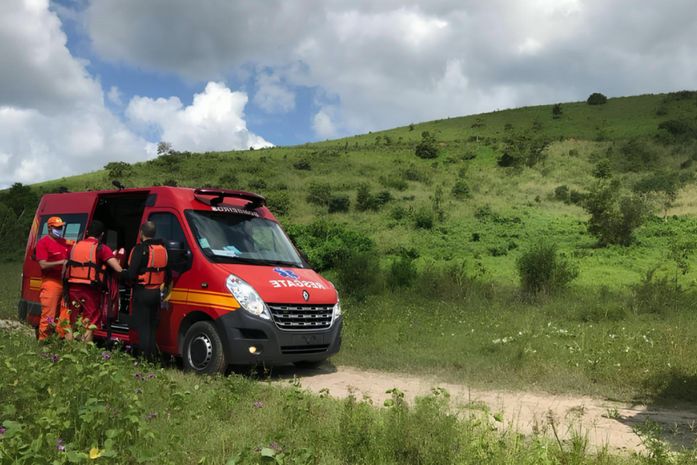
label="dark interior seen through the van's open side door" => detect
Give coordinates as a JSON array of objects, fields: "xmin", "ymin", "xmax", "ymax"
[{"xmin": 93, "ymin": 192, "xmax": 148, "ymax": 332}]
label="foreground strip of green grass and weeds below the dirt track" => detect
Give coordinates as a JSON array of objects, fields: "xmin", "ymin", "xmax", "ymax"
[{"xmin": 0, "ymin": 330, "xmax": 694, "ymax": 465}]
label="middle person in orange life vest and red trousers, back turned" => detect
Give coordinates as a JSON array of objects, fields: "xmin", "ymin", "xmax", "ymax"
[{"xmin": 59, "ymin": 220, "xmax": 123, "ymax": 342}]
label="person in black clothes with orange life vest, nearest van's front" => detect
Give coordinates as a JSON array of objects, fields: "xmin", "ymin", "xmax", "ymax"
[{"xmin": 124, "ymin": 221, "xmax": 170, "ymax": 361}]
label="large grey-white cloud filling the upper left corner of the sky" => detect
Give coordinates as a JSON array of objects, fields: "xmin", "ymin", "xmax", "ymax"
[{"xmin": 0, "ymin": 0, "xmax": 146, "ymax": 187}]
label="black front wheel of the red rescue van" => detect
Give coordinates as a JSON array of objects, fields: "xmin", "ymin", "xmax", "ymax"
[{"xmin": 182, "ymin": 321, "xmax": 227, "ymax": 374}]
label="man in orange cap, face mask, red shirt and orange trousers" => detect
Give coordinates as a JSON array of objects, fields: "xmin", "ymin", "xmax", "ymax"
[{"xmin": 36, "ymin": 216, "xmax": 72, "ymax": 341}]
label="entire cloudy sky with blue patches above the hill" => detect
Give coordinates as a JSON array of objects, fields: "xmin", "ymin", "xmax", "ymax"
[{"xmin": 0, "ymin": 0, "xmax": 697, "ymax": 188}]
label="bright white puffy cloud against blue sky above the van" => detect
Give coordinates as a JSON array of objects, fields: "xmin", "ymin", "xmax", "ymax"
[{"xmin": 126, "ymin": 82, "xmax": 273, "ymax": 151}]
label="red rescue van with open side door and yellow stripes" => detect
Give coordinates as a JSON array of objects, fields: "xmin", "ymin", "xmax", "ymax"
[{"xmin": 19, "ymin": 187, "xmax": 342, "ymax": 373}]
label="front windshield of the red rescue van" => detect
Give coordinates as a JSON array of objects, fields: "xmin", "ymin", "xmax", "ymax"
[{"xmin": 186, "ymin": 210, "xmax": 304, "ymax": 268}]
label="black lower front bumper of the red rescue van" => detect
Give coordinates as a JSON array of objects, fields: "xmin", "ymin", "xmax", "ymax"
[{"xmin": 216, "ymin": 309, "xmax": 343, "ymax": 365}]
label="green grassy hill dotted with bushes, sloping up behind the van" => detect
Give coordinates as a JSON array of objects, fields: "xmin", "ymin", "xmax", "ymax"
[{"xmin": 25, "ymin": 92, "xmax": 697, "ymax": 287}]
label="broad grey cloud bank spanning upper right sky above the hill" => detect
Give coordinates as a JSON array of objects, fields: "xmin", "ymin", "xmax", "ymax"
[{"xmin": 87, "ymin": 0, "xmax": 697, "ymax": 138}]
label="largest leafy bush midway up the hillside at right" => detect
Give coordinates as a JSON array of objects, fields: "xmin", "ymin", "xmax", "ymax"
[{"xmin": 583, "ymin": 182, "xmax": 649, "ymax": 246}]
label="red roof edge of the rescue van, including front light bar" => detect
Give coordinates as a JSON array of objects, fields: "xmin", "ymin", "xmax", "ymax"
[{"xmin": 39, "ymin": 186, "xmax": 276, "ymax": 221}]
